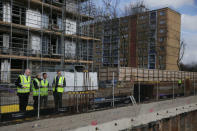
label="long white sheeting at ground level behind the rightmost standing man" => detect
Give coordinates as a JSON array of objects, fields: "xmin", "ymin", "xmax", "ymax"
[{"xmin": 43, "ymin": 72, "xmax": 98, "ymax": 92}]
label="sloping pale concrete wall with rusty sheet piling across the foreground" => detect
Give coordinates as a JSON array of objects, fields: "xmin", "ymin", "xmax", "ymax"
[{"xmin": 1, "ymin": 96, "xmax": 197, "ymax": 131}]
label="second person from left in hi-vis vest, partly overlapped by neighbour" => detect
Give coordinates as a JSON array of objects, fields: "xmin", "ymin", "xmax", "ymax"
[{"xmin": 32, "ymin": 74, "xmax": 41, "ymax": 111}]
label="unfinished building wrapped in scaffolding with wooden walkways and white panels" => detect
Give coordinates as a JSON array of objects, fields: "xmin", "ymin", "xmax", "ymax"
[{"xmin": 0, "ymin": 0, "xmax": 98, "ymax": 83}]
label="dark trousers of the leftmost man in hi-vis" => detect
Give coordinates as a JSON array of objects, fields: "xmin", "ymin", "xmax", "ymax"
[{"xmin": 17, "ymin": 93, "xmax": 29, "ymax": 112}]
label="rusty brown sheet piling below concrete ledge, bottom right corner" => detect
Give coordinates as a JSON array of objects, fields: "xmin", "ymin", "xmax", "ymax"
[{"xmin": 131, "ymin": 111, "xmax": 197, "ymax": 131}]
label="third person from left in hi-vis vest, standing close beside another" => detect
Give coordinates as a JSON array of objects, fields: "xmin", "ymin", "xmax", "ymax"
[{"xmin": 40, "ymin": 73, "xmax": 49, "ymax": 107}]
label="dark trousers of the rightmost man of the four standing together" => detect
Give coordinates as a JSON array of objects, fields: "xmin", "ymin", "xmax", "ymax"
[{"xmin": 53, "ymin": 92, "xmax": 62, "ymax": 111}]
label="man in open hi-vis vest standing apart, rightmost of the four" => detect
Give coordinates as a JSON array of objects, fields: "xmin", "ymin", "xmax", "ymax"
[{"xmin": 52, "ymin": 71, "xmax": 66, "ymax": 111}]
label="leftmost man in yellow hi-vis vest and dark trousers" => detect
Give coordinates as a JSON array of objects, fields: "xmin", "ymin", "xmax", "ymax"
[{"xmin": 15, "ymin": 69, "xmax": 31, "ymax": 112}]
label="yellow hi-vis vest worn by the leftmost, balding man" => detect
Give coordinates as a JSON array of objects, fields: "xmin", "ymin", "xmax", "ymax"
[{"xmin": 17, "ymin": 75, "xmax": 31, "ymax": 93}]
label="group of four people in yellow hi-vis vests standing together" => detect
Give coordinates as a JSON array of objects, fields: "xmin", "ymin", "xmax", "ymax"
[{"xmin": 15, "ymin": 69, "xmax": 66, "ymax": 112}]
